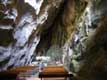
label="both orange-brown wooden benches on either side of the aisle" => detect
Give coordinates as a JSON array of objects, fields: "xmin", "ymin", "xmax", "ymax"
[{"xmin": 0, "ymin": 66, "xmax": 73, "ymax": 79}]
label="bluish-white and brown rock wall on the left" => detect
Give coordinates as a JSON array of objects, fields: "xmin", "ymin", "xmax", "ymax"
[{"xmin": 0, "ymin": 0, "xmax": 63, "ymax": 70}]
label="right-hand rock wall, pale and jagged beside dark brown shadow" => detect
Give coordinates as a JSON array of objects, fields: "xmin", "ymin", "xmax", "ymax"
[{"xmin": 71, "ymin": 0, "xmax": 107, "ymax": 80}]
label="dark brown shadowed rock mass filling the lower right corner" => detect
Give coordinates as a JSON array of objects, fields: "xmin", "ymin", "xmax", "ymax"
[{"xmin": 77, "ymin": 18, "xmax": 107, "ymax": 80}]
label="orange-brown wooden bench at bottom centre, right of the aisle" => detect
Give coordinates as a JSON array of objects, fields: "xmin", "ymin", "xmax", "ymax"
[{"xmin": 39, "ymin": 66, "xmax": 73, "ymax": 80}]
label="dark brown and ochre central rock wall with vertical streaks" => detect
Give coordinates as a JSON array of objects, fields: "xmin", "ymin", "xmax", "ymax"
[{"xmin": 36, "ymin": 0, "xmax": 87, "ymax": 54}]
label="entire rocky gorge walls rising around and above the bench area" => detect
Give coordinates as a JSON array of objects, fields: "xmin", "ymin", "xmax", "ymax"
[{"xmin": 0, "ymin": 0, "xmax": 107, "ymax": 80}]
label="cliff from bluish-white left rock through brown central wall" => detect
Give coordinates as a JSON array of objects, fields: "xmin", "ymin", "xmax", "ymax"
[{"xmin": 0, "ymin": 0, "xmax": 87, "ymax": 70}]
